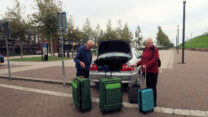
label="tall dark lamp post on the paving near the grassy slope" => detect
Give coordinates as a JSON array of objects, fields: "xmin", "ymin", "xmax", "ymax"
[{"xmin": 182, "ymin": 0, "xmax": 186, "ymax": 64}]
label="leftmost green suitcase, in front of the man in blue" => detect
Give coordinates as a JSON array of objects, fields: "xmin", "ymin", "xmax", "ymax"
[{"xmin": 72, "ymin": 76, "xmax": 92, "ymax": 112}]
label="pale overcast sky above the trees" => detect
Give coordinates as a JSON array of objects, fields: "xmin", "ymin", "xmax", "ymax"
[{"xmin": 0, "ymin": 0, "xmax": 208, "ymax": 43}]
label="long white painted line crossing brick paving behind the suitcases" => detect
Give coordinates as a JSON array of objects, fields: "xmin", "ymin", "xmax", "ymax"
[{"xmin": 0, "ymin": 84, "xmax": 208, "ymax": 117}]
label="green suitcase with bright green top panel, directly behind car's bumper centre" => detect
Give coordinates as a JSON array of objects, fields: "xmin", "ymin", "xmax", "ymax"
[{"xmin": 99, "ymin": 77, "xmax": 122, "ymax": 113}]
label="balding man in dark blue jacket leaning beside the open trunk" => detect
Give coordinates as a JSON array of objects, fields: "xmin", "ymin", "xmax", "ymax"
[{"xmin": 74, "ymin": 40, "xmax": 94, "ymax": 78}]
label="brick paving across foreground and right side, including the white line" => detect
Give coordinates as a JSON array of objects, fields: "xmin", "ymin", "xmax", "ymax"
[{"xmin": 0, "ymin": 50, "xmax": 208, "ymax": 117}]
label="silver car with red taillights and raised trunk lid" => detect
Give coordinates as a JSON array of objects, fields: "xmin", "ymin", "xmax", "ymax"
[{"xmin": 89, "ymin": 41, "xmax": 141, "ymax": 84}]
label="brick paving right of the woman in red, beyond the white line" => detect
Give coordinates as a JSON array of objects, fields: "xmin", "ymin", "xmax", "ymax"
[{"xmin": 158, "ymin": 51, "xmax": 208, "ymax": 111}]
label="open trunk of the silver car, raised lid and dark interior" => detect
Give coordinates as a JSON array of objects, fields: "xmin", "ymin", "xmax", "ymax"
[{"xmin": 95, "ymin": 40, "xmax": 132, "ymax": 71}]
